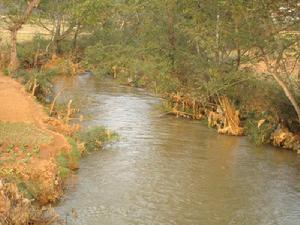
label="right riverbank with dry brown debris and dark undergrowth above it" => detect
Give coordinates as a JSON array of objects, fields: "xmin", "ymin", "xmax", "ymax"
[{"xmin": 103, "ymin": 74, "xmax": 300, "ymax": 154}]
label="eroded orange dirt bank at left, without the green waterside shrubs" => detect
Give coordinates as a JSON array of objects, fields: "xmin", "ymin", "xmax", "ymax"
[{"xmin": 0, "ymin": 74, "xmax": 71, "ymax": 225}]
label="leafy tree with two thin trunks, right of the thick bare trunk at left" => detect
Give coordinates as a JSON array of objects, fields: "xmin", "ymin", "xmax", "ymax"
[{"xmin": 36, "ymin": 0, "xmax": 107, "ymax": 55}]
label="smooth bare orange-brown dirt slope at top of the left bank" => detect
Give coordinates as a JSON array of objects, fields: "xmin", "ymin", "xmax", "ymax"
[{"xmin": 0, "ymin": 73, "xmax": 70, "ymax": 158}]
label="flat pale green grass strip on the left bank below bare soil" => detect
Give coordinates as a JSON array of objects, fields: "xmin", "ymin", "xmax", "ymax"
[{"xmin": 0, "ymin": 122, "xmax": 52, "ymax": 146}]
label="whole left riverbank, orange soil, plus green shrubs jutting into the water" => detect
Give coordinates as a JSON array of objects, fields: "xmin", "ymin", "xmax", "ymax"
[{"xmin": 0, "ymin": 74, "xmax": 113, "ymax": 225}]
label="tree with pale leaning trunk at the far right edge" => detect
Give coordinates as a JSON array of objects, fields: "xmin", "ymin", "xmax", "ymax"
[{"xmin": 245, "ymin": 0, "xmax": 300, "ymax": 122}]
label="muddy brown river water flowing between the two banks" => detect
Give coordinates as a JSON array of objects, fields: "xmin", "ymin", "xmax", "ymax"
[{"xmin": 57, "ymin": 75, "xmax": 300, "ymax": 225}]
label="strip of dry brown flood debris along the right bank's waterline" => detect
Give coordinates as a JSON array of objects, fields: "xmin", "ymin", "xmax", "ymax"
[{"xmin": 164, "ymin": 93, "xmax": 300, "ymax": 154}]
